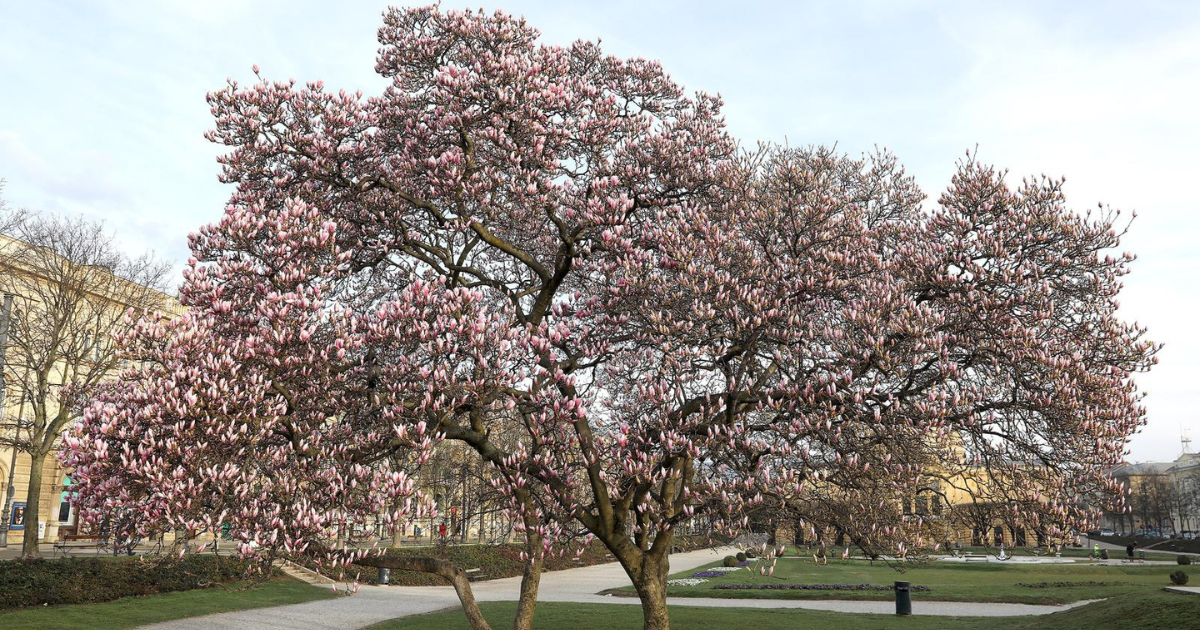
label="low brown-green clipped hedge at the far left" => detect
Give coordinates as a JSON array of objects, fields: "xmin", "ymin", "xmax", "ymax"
[{"xmin": 0, "ymin": 556, "xmax": 252, "ymax": 610}]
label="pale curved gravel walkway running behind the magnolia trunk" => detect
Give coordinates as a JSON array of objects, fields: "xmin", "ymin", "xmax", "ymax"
[{"xmin": 133, "ymin": 550, "xmax": 1104, "ymax": 630}]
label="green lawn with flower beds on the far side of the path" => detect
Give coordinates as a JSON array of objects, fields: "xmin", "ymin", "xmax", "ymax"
[{"xmin": 612, "ymin": 557, "xmax": 1185, "ymax": 607}]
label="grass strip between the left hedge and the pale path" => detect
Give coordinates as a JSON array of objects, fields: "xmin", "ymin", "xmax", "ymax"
[{"xmin": 0, "ymin": 577, "xmax": 336, "ymax": 630}]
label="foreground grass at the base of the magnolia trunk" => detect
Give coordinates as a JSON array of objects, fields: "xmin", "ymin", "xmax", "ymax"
[{"xmin": 371, "ymin": 590, "xmax": 1200, "ymax": 630}]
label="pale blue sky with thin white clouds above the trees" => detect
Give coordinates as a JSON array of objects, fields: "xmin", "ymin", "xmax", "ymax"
[{"xmin": 0, "ymin": 0, "xmax": 1200, "ymax": 461}]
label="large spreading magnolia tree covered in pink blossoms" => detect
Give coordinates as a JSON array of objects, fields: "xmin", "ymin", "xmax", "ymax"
[{"xmin": 68, "ymin": 8, "xmax": 1154, "ymax": 629}]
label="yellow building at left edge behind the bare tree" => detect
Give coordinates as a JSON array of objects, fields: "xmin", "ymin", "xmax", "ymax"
[{"xmin": 0, "ymin": 229, "xmax": 181, "ymax": 550}]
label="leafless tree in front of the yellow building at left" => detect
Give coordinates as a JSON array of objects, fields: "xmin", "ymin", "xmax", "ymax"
[{"xmin": 0, "ymin": 209, "xmax": 172, "ymax": 558}]
